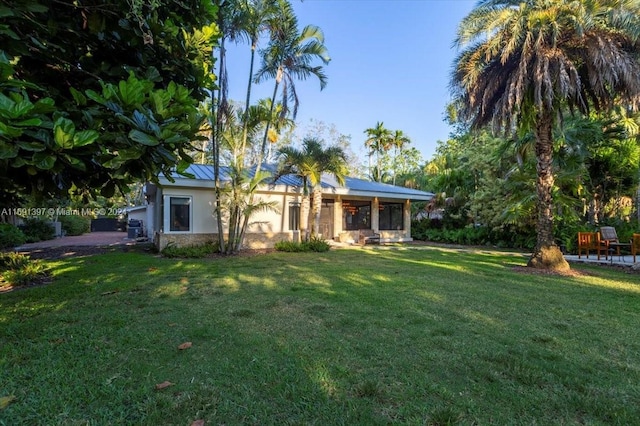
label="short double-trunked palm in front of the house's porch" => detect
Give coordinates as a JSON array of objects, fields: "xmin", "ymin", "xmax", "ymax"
[{"xmin": 275, "ymin": 138, "xmax": 347, "ymax": 240}]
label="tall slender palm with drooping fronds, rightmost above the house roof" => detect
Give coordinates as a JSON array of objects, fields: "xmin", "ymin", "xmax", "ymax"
[{"xmin": 255, "ymin": 0, "xmax": 330, "ymax": 166}]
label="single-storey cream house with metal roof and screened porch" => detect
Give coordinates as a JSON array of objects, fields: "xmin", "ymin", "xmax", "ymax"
[{"xmin": 138, "ymin": 164, "xmax": 433, "ymax": 250}]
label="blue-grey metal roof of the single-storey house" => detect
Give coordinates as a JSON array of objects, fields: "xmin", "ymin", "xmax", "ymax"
[{"xmin": 163, "ymin": 164, "xmax": 434, "ymax": 201}]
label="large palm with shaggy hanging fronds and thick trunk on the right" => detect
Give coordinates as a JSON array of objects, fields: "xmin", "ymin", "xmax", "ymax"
[{"xmin": 451, "ymin": 0, "xmax": 640, "ymax": 269}]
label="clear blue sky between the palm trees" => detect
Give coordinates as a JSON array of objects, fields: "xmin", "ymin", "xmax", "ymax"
[{"xmin": 228, "ymin": 0, "xmax": 476, "ymax": 161}]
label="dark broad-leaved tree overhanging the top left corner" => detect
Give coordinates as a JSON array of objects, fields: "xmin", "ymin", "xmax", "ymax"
[{"xmin": 0, "ymin": 0, "xmax": 217, "ymax": 203}]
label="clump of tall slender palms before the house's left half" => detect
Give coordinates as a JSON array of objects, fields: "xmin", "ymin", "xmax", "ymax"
[{"xmin": 211, "ymin": 0, "xmax": 329, "ymax": 254}]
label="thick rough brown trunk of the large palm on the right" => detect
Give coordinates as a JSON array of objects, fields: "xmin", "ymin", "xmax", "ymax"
[{"xmin": 527, "ymin": 110, "xmax": 570, "ymax": 271}]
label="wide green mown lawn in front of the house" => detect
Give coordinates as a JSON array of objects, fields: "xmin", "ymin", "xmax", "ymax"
[{"xmin": 0, "ymin": 248, "xmax": 640, "ymax": 425}]
